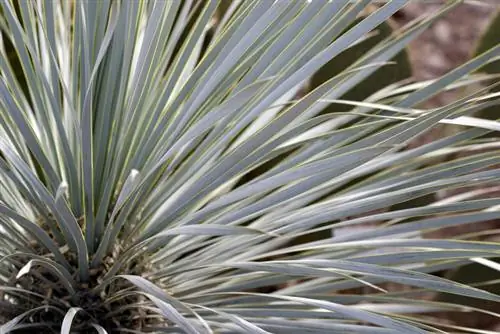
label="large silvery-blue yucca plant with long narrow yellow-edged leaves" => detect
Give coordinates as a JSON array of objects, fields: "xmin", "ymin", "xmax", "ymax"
[{"xmin": 0, "ymin": 0, "xmax": 500, "ymax": 334}]
